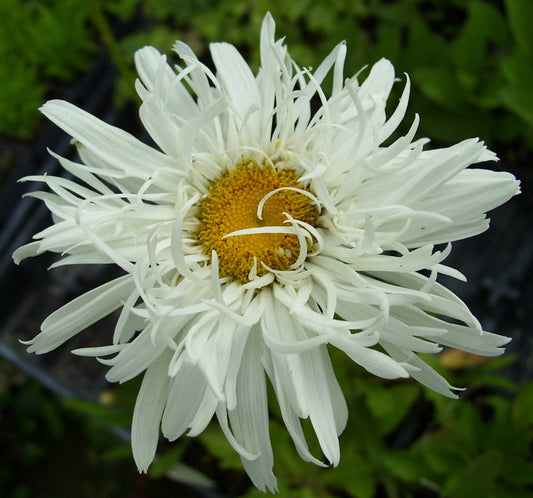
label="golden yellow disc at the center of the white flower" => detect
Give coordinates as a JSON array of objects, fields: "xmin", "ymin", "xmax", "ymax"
[{"xmin": 195, "ymin": 161, "xmax": 319, "ymax": 283}]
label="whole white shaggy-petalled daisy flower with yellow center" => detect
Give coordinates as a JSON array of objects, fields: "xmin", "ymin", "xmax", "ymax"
[{"xmin": 14, "ymin": 15, "xmax": 519, "ymax": 491}]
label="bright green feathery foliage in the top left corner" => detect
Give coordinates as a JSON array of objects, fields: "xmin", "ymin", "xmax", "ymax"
[{"xmin": 0, "ymin": 0, "xmax": 96, "ymax": 139}]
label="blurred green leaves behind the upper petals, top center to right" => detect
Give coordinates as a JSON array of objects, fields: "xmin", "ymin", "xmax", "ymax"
[{"xmin": 115, "ymin": 0, "xmax": 533, "ymax": 159}]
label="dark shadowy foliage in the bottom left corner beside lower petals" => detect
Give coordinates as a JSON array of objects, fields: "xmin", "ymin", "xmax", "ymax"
[{"xmin": 0, "ymin": 359, "xmax": 193, "ymax": 498}]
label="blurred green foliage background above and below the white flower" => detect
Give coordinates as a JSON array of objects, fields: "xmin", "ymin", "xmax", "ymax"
[{"xmin": 0, "ymin": 0, "xmax": 533, "ymax": 498}]
